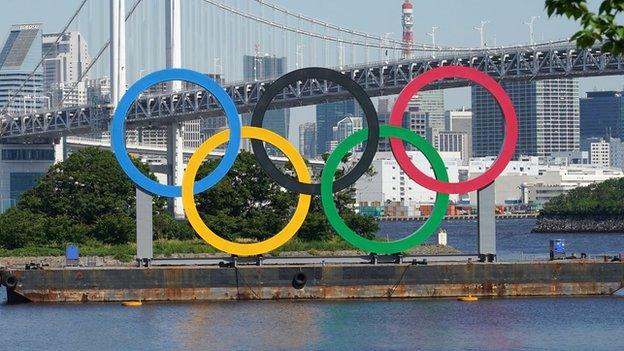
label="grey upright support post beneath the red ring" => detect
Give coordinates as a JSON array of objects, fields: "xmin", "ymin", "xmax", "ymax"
[{"xmin": 477, "ymin": 182, "xmax": 496, "ymax": 262}]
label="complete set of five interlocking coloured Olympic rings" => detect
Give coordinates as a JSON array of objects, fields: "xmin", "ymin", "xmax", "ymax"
[{"xmin": 111, "ymin": 66, "xmax": 518, "ymax": 256}]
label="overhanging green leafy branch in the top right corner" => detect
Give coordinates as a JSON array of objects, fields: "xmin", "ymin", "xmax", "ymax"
[{"xmin": 546, "ymin": 0, "xmax": 624, "ymax": 54}]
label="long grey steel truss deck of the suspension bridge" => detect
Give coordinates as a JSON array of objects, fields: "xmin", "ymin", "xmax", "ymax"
[{"xmin": 0, "ymin": 44, "xmax": 624, "ymax": 139}]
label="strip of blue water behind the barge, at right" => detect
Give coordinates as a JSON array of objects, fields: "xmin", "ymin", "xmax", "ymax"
[{"xmin": 377, "ymin": 219, "xmax": 624, "ymax": 260}]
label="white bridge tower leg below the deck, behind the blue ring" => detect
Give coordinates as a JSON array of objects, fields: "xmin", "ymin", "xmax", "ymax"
[{"xmin": 167, "ymin": 122, "xmax": 184, "ymax": 219}]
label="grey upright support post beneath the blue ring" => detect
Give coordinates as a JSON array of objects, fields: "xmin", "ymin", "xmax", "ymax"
[{"xmin": 136, "ymin": 188, "xmax": 154, "ymax": 267}]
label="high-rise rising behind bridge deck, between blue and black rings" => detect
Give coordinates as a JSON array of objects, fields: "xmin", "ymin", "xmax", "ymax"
[{"xmin": 243, "ymin": 54, "xmax": 290, "ymax": 147}]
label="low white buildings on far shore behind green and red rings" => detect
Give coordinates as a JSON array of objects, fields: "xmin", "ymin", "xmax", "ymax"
[{"xmin": 356, "ymin": 151, "xmax": 624, "ymax": 208}]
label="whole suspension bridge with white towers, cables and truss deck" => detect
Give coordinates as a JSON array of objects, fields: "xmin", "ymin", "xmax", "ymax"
[{"xmin": 0, "ymin": 0, "xmax": 624, "ymax": 223}]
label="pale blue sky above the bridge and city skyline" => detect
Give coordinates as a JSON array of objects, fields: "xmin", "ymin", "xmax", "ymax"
[{"xmin": 0, "ymin": 0, "xmax": 624, "ymax": 145}]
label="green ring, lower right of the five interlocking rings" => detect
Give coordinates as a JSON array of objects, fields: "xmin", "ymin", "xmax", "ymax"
[{"xmin": 321, "ymin": 125, "xmax": 449, "ymax": 254}]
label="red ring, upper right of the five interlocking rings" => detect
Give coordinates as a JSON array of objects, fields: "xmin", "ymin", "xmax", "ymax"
[{"xmin": 390, "ymin": 66, "xmax": 518, "ymax": 194}]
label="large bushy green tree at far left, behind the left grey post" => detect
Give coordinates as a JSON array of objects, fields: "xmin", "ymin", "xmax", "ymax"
[{"xmin": 0, "ymin": 148, "xmax": 185, "ymax": 249}]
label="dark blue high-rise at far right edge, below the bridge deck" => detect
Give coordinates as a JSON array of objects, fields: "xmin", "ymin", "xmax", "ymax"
[{"xmin": 580, "ymin": 91, "xmax": 624, "ymax": 143}]
